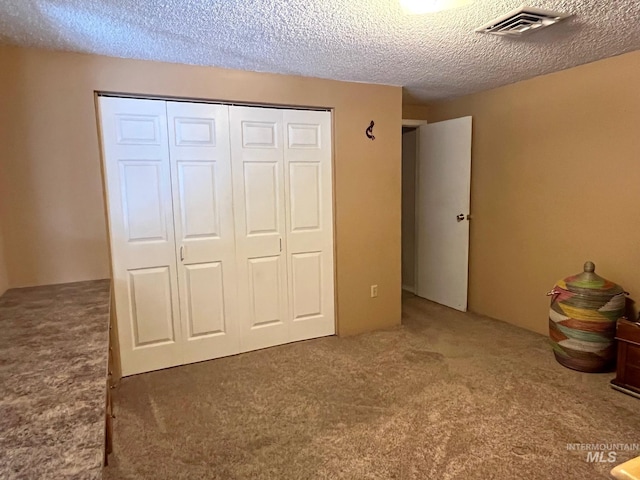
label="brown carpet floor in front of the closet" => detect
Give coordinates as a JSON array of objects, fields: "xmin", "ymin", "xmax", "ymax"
[{"xmin": 104, "ymin": 296, "xmax": 640, "ymax": 480}]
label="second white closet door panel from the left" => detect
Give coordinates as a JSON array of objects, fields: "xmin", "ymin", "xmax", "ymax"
[{"xmin": 167, "ymin": 102, "xmax": 240, "ymax": 363}]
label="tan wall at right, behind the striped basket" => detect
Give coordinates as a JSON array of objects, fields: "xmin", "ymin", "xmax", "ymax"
[{"xmin": 429, "ymin": 51, "xmax": 640, "ymax": 333}]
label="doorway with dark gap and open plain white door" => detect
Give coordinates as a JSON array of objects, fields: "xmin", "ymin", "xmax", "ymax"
[{"xmin": 401, "ymin": 117, "xmax": 472, "ymax": 311}]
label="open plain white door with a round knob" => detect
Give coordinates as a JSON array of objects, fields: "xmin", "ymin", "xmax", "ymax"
[{"xmin": 416, "ymin": 117, "xmax": 471, "ymax": 312}]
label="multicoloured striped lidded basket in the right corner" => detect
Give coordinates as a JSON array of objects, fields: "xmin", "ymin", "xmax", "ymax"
[{"xmin": 547, "ymin": 262, "xmax": 626, "ymax": 372}]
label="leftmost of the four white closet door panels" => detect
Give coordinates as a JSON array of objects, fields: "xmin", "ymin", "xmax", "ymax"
[{"xmin": 99, "ymin": 97, "xmax": 183, "ymax": 375}]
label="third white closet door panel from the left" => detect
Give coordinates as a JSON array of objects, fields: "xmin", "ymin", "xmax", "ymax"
[{"xmin": 229, "ymin": 107, "xmax": 290, "ymax": 351}]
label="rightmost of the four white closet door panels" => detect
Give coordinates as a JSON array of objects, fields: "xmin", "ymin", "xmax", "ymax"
[{"xmin": 283, "ymin": 110, "xmax": 335, "ymax": 341}]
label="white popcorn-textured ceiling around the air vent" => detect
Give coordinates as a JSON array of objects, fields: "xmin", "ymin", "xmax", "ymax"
[{"xmin": 0, "ymin": 0, "xmax": 640, "ymax": 103}]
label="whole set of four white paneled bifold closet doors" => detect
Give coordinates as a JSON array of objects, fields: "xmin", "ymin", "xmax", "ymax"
[{"xmin": 100, "ymin": 97, "xmax": 335, "ymax": 375}]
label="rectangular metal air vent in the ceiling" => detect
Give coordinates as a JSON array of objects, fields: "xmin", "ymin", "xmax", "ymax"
[{"xmin": 476, "ymin": 7, "xmax": 571, "ymax": 37}]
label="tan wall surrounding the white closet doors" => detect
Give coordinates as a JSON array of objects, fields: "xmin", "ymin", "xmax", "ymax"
[{"xmin": 0, "ymin": 47, "xmax": 402, "ymax": 334}]
